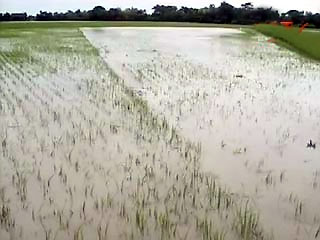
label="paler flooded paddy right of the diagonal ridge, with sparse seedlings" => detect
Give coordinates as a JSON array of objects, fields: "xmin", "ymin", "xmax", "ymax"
[{"xmin": 83, "ymin": 28, "xmax": 320, "ymax": 240}]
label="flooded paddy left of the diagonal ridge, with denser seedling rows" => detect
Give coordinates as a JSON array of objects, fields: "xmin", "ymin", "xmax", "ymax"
[{"xmin": 0, "ymin": 29, "xmax": 212, "ymax": 240}]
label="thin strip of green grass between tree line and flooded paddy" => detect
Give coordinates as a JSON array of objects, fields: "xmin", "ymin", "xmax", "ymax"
[{"xmin": 0, "ymin": 21, "xmax": 250, "ymax": 30}]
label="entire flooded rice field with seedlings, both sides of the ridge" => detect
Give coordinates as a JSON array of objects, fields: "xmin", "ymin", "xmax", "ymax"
[{"xmin": 0, "ymin": 23, "xmax": 320, "ymax": 240}]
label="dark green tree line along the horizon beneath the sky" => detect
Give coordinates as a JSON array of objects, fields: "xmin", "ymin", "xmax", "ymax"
[{"xmin": 0, "ymin": 2, "xmax": 320, "ymax": 28}]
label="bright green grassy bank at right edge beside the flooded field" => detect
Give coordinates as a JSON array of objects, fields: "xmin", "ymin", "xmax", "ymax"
[{"xmin": 255, "ymin": 24, "xmax": 320, "ymax": 61}]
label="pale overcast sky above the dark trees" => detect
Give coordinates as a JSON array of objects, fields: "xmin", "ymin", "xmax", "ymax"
[{"xmin": 0, "ymin": 0, "xmax": 320, "ymax": 14}]
